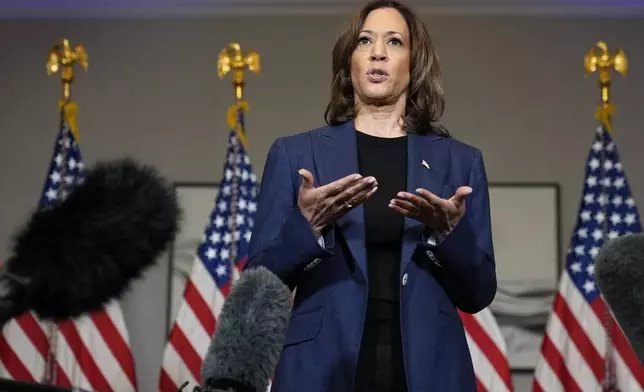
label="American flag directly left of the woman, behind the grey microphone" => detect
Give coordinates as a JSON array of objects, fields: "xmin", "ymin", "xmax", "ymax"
[{"xmin": 159, "ymin": 105, "xmax": 258, "ymax": 392}]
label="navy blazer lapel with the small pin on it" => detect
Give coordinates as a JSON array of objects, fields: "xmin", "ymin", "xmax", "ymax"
[{"xmin": 400, "ymin": 133, "xmax": 449, "ymax": 274}]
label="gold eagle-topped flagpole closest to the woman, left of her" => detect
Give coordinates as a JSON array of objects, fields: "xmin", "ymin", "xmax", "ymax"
[{"xmin": 217, "ymin": 42, "xmax": 261, "ymax": 276}]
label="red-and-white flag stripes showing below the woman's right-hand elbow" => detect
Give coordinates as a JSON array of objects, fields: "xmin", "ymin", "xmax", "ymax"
[{"xmin": 459, "ymin": 308, "xmax": 514, "ymax": 392}]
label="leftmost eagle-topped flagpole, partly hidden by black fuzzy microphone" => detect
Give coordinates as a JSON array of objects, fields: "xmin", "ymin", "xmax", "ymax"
[{"xmin": 42, "ymin": 38, "xmax": 89, "ymax": 385}]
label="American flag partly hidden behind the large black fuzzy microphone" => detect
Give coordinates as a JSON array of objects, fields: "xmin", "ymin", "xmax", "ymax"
[{"xmin": 0, "ymin": 103, "xmax": 136, "ymax": 392}]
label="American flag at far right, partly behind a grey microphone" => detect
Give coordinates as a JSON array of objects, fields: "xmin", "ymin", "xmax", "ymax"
[{"xmin": 533, "ymin": 126, "xmax": 644, "ymax": 392}]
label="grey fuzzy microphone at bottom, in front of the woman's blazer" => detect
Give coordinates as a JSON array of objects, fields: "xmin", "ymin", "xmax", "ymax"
[{"xmin": 197, "ymin": 267, "xmax": 291, "ymax": 392}]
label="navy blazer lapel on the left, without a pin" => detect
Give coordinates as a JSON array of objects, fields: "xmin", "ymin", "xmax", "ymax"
[{"xmin": 312, "ymin": 121, "xmax": 367, "ymax": 280}]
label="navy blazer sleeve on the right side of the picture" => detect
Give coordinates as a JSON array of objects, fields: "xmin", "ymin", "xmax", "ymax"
[{"xmin": 421, "ymin": 151, "xmax": 497, "ymax": 313}]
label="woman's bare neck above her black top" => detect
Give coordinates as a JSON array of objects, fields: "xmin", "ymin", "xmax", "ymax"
[{"xmin": 354, "ymin": 95, "xmax": 405, "ymax": 138}]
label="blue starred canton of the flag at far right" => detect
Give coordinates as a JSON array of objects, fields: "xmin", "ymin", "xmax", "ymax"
[{"xmin": 566, "ymin": 126, "xmax": 642, "ymax": 303}]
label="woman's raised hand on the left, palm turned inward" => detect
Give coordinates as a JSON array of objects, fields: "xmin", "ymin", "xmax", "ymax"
[{"xmin": 297, "ymin": 169, "xmax": 378, "ymax": 237}]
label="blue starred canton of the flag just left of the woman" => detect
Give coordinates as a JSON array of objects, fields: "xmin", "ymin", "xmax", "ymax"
[{"xmin": 198, "ymin": 109, "xmax": 258, "ymax": 289}]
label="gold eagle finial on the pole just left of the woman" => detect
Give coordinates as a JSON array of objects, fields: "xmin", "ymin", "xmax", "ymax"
[{"xmin": 217, "ymin": 42, "xmax": 261, "ymax": 102}]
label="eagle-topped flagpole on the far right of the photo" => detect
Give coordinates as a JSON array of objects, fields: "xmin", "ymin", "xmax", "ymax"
[{"xmin": 584, "ymin": 41, "xmax": 628, "ymax": 392}]
